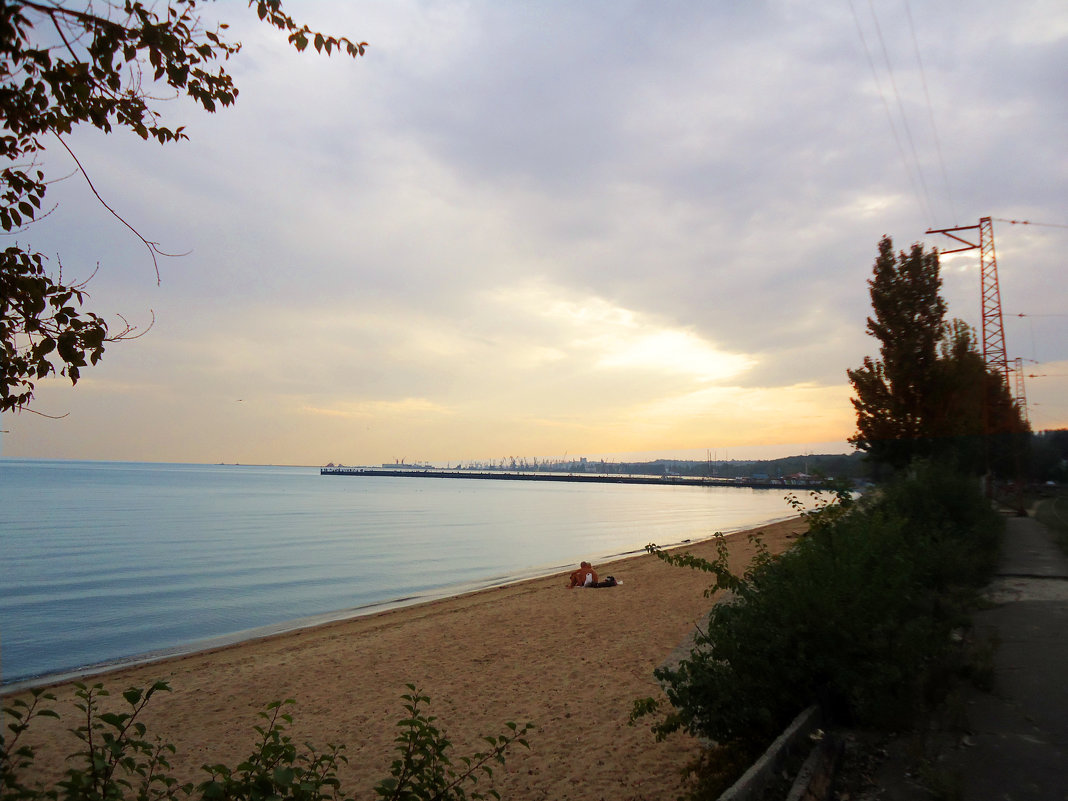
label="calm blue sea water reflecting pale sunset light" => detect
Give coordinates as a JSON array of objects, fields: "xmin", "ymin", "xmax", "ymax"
[{"xmin": 0, "ymin": 460, "xmax": 789, "ymax": 685}]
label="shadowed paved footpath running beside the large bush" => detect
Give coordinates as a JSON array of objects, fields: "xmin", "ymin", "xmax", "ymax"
[{"xmin": 927, "ymin": 517, "xmax": 1068, "ymax": 801}]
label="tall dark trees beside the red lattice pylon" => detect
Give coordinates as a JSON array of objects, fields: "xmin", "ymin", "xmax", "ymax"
[{"xmin": 848, "ymin": 237, "xmax": 1026, "ymax": 472}]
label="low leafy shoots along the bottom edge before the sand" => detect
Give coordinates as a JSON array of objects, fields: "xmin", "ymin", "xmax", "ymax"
[{"xmin": 0, "ymin": 681, "xmax": 533, "ymax": 801}]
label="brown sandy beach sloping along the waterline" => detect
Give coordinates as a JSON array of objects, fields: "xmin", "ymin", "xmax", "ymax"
[{"xmin": 10, "ymin": 519, "xmax": 804, "ymax": 801}]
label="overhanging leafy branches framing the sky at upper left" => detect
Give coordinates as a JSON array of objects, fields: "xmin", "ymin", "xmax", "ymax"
[{"xmin": 0, "ymin": 0, "xmax": 366, "ymax": 411}]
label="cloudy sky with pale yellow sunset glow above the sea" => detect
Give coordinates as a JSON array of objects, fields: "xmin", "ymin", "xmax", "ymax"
[{"xmin": 0, "ymin": 0, "xmax": 1068, "ymax": 466}]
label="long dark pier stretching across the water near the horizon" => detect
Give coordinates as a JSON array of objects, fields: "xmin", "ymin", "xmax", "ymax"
[{"xmin": 319, "ymin": 467, "xmax": 823, "ymax": 489}]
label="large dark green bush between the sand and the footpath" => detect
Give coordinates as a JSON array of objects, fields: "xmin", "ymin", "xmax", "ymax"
[{"xmin": 635, "ymin": 466, "xmax": 1001, "ymax": 754}]
